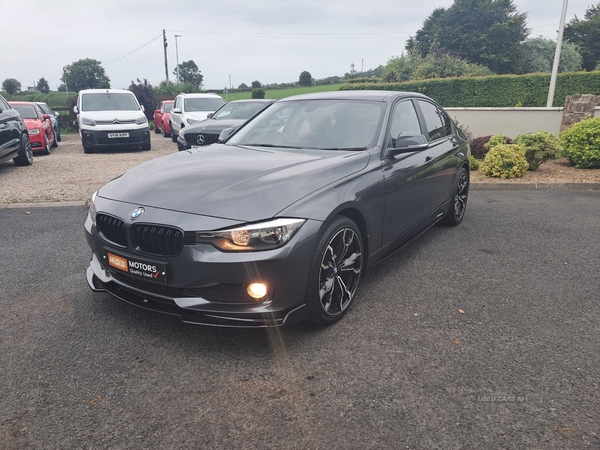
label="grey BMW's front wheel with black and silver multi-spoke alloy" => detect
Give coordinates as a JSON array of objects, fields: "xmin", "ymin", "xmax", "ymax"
[{"xmin": 305, "ymin": 216, "xmax": 364, "ymax": 325}]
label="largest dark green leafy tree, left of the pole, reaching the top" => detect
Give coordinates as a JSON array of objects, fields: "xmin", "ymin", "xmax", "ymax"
[{"xmin": 406, "ymin": 0, "xmax": 529, "ymax": 73}]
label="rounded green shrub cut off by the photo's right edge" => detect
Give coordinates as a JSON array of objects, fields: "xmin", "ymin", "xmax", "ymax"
[{"xmin": 560, "ymin": 117, "xmax": 600, "ymax": 169}]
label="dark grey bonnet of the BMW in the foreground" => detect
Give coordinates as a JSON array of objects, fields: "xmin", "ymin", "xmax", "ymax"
[{"xmin": 98, "ymin": 144, "xmax": 369, "ymax": 222}]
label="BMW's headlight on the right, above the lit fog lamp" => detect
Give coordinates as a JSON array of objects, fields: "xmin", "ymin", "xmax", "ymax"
[{"xmin": 196, "ymin": 219, "xmax": 306, "ymax": 252}]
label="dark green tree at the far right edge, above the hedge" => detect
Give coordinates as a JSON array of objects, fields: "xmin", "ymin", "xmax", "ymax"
[{"xmin": 564, "ymin": 2, "xmax": 600, "ymax": 70}]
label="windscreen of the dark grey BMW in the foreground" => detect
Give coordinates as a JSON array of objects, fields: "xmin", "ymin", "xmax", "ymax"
[{"xmin": 227, "ymin": 100, "xmax": 385, "ymax": 150}]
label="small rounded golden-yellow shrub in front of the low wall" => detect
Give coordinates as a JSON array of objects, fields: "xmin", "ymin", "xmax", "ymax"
[{"xmin": 480, "ymin": 144, "xmax": 529, "ymax": 178}]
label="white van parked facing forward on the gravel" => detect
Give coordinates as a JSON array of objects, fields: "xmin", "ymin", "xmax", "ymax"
[{"xmin": 73, "ymin": 89, "xmax": 151, "ymax": 153}]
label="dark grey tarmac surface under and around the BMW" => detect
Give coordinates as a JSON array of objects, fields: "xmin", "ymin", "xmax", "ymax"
[{"xmin": 0, "ymin": 186, "xmax": 600, "ymax": 449}]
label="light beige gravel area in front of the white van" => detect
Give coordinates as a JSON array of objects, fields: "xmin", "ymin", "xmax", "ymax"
[{"xmin": 0, "ymin": 131, "xmax": 177, "ymax": 204}]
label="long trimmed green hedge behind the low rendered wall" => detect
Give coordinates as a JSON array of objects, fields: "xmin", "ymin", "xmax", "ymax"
[{"xmin": 340, "ymin": 71, "xmax": 600, "ymax": 108}]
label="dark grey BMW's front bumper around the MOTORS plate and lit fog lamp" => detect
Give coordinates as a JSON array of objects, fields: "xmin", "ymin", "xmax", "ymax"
[{"xmin": 84, "ymin": 207, "xmax": 319, "ymax": 328}]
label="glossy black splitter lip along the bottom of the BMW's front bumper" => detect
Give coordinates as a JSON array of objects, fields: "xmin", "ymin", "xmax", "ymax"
[{"xmin": 86, "ymin": 254, "xmax": 308, "ymax": 328}]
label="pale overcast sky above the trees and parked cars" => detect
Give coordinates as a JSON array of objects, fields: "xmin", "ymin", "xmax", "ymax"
[{"xmin": 0, "ymin": 0, "xmax": 598, "ymax": 91}]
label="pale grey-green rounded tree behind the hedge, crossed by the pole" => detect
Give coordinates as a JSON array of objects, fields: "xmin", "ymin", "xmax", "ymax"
[{"xmin": 515, "ymin": 37, "xmax": 582, "ymax": 74}]
